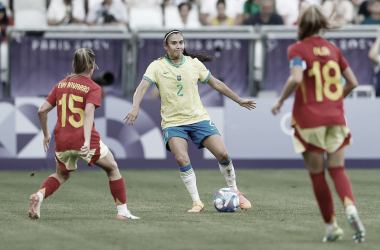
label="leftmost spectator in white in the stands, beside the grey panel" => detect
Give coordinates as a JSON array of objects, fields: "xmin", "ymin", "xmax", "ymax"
[{"xmin": 47, "ymin": 0, "xmax": 86, "ymax": 26}]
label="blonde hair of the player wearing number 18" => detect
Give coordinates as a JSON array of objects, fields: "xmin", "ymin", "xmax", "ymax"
[{"xmin": 298, "ymin": 4, "xmax": 339, "ymax": 41}]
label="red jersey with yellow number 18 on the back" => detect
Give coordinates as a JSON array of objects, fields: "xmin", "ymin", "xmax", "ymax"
[{"xmin": 288, "ymin": 36, "xmax": 349, "ymax": 129}]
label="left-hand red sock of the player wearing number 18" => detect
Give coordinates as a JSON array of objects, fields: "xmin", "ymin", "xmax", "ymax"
[{"xmin": 310, "ymin": 171, "xmax": 336, "ymax": 223}]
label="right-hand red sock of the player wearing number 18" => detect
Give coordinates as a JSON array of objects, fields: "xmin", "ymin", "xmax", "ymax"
[{"xmin": 329, "ymin": 167, "xmax": 355, "ymax": 207}]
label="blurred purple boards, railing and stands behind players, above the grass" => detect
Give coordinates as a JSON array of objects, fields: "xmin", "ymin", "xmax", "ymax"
[{"xmin": 0, "ymin": 0, "xmax": 380, "ymax": 170}]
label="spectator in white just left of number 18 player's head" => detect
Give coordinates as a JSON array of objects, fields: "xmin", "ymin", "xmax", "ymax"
[{"xmin": 276, "ymin": 0, "xmax": 300, "ymax": 26}]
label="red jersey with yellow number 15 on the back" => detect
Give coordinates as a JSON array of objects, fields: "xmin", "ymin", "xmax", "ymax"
[{"xmin": 46, "ymin": 76, "xmax": 102, "ymax": 152}]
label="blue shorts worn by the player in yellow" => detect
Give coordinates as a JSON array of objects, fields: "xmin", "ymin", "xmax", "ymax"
[{"xmin": 162, "ymin": 120, "xmax": 219, "ymax": 151}]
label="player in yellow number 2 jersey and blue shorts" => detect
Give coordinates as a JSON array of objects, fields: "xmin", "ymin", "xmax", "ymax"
[{"xmin": 124, "ymin": 30, "xmax": 256, "ymax": 213}]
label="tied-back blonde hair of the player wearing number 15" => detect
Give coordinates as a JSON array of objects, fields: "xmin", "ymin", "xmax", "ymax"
[{"xmin": 67, "ymin": 48, "xmax": 98, "ymax": 78}]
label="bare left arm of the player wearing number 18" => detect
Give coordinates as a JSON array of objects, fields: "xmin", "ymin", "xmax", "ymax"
[{"xmin": 272, "ymin": 65, "xmax": 303, "ymax": 115}]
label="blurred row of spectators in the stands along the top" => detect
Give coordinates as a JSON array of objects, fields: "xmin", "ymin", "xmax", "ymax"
[{"xmin": 0, "ymin": 0, "xmax": 380, "ymax": 31}]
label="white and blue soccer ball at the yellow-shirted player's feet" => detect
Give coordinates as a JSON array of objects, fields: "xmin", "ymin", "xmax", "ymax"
[{"xmin": 214, "ymin": 188, "xmax": 240, "ymax": 212}]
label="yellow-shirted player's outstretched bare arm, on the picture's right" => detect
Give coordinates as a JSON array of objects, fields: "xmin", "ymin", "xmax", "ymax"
[{"xmin": 207, "ymin": 75, "xmax": 256, "ymax": 110}]
